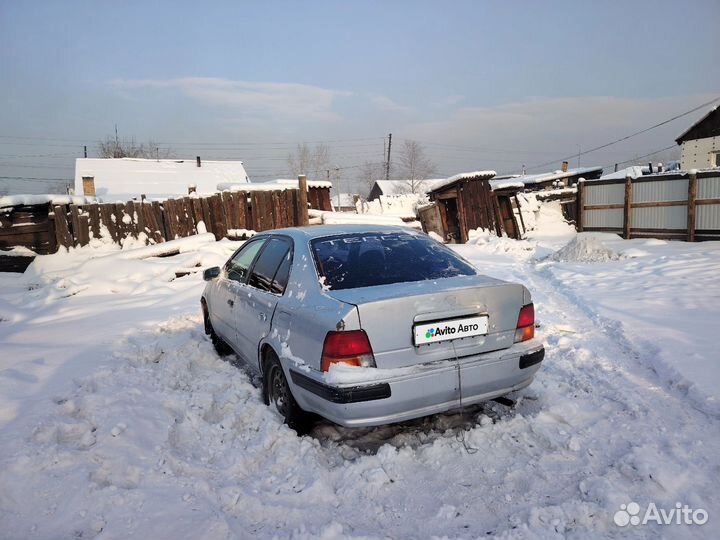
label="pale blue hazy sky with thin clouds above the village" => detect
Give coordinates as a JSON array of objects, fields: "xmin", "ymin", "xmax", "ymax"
[{"xmin": 0, "ymin": 0, "xmax": 720, "ymax": 193}]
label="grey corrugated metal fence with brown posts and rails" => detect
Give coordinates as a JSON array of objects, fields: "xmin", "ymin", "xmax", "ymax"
[{"xmin": 577, "ymin": 169, "xmax": 720, "ymax": 242}]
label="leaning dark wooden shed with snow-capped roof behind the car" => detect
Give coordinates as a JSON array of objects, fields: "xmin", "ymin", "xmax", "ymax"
[{"xmin": 418, "ymin": 171, "xmax": 520, "ymax": 243}]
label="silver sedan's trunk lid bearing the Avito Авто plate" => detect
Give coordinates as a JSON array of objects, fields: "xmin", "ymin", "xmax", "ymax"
[{"xmin": 327, "ymin": 275, "xmax": 524, "ymax": 368}]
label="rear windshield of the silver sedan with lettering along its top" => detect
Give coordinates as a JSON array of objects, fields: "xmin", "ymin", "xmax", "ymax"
[{"xmin": 311, "ymin": 233, "xmax": 477, "ymax": 290}]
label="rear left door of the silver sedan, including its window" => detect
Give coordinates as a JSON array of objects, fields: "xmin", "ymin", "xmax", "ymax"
[{"xmin": 236, "ymin": 236, "xmax": 292, "ymax": 368}]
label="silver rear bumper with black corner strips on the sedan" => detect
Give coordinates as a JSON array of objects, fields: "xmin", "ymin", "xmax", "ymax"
[{"xmin": 290, "ymin": 340, "xmax": 545, "ymax": 427}]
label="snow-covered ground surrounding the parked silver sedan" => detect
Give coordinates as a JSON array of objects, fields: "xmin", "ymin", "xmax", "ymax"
[{"xmin": 0, "ymin": 205, "xmax": 720, "ymax": 540}]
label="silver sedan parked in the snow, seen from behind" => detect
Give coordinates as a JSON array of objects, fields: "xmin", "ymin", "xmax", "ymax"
[{"xmin": 201, "ymin": 225, "xmax": 545, "ymax": 430}]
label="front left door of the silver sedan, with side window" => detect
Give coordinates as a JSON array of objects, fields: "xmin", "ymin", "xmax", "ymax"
[{"xmin": 210, "ymin": 238, "xmax": 267, "ymax": 349}]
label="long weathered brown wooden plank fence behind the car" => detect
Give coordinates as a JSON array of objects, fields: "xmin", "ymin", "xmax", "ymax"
[{"xmin": 0, "ymin": 179, "xmax": 332, "ymax": 260}]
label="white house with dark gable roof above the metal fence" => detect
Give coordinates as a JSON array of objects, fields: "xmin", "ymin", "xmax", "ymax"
[{"xmin": 675, "ymin": 106, "xmax": 720, "ymax": 171}]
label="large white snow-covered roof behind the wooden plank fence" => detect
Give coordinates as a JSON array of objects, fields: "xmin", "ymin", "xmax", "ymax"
[{"xmin": 75, "ymin": 158, "xmax": 250, "ymax": 204}]
